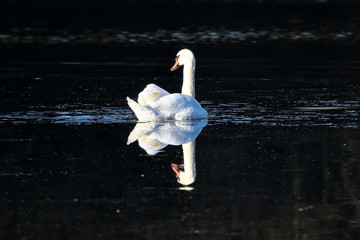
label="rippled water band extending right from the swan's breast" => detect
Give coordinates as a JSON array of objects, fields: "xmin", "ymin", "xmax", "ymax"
[{"xmin": 205, "ymin": 103, "xmax": 360, "ymax": 128}]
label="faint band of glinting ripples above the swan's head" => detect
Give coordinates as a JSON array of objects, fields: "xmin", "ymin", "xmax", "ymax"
[{"xmin": 0, "ymin": 26, "xmax": 356, "ymax": 46}]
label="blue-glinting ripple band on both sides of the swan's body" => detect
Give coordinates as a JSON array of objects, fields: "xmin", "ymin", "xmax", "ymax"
[{"xmin": 0, "ymin": 103, "xmax": 360, "ymax": 128}]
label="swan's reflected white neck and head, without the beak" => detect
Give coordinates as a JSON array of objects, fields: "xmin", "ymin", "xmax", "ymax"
[{"xmin": 180, "ymin": 140, "xmax": 196, "ymax": 185}]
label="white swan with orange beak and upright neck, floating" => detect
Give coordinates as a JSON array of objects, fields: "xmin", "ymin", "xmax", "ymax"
[{"xmin": 126, "ymin": 49, "xmax": 208, "ymax": 121}]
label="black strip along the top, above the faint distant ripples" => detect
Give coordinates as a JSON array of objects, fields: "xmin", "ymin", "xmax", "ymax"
[{"xmin": 0, "ymin": 0, "xmax": 360, "ymax": 47}]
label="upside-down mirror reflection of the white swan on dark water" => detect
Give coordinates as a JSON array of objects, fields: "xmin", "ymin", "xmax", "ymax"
[{"xmin": 127, "ymin": 120, "xmax": 207, "ymax": 185}]
